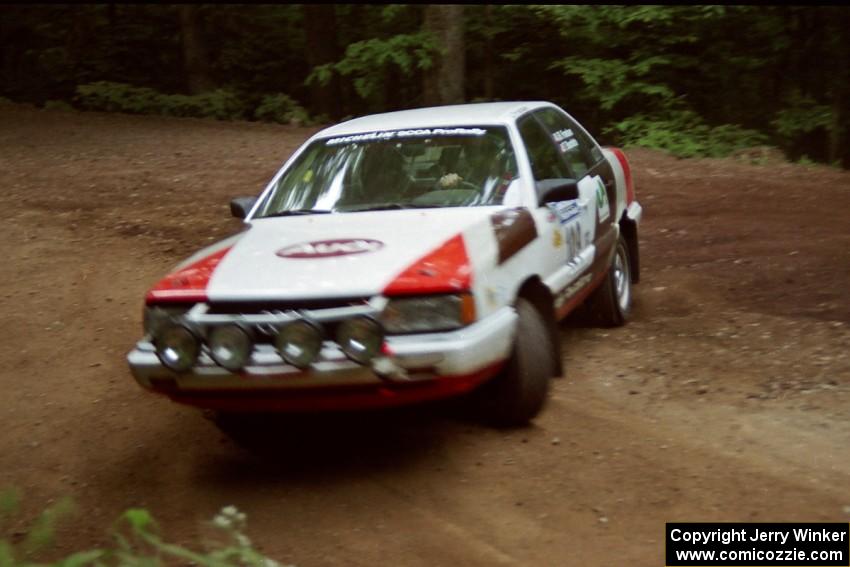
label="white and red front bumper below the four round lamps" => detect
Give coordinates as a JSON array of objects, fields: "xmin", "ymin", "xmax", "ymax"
[{"xmin": 127, "ymin": 307, "xmax": 517, "ymax": 411}]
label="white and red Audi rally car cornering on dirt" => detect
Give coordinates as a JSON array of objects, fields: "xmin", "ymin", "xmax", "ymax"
[{"xmin": 128, "ymin": 102, "xmax": 641, "ymax": 424}]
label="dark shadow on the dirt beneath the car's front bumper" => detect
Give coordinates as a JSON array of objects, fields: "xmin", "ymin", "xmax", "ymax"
[{"xmin": 186, "ymin": 403, "xmax": 487, "ymax": 484}]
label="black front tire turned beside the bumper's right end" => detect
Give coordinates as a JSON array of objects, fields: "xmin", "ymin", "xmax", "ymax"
[{"xmin": 476, "ymin": 298, "xmax": 555, "ymax": 427}]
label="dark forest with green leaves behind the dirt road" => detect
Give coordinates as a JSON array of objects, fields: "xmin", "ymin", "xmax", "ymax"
[{"xmin": 0, "ymin": 4, "xmax": 850, "ymax": 168}]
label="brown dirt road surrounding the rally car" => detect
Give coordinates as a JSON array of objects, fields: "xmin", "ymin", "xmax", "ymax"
[{"xmin": 0, "ymin": 106, "xmax": 850, "ymax": 567}]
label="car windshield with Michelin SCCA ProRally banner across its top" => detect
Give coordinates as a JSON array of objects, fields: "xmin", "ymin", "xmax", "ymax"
[{"xmin": 255, "ymin": 126, "xmax": 517, "ymax": 218}]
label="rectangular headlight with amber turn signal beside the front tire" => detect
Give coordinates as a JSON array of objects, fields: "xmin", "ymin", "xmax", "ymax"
[{"xmin": 381, "ymin": 293, "xmax": 475, "ymax": 333}]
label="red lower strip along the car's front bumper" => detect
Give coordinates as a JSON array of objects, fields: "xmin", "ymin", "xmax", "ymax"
[{"xmin": 162, "ymin": 361, "xmax": 505, "ymax": 412}]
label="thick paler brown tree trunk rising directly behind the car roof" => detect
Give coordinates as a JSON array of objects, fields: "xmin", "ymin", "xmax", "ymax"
[{"xmin": 423, "ymin": 4, "xmax": 466, "ymax": 105}]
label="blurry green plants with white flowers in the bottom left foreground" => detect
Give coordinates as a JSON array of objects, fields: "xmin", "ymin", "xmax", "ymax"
[{"xmin": 0, "ymin": 491, "xmax": 282, "ymax": 567}]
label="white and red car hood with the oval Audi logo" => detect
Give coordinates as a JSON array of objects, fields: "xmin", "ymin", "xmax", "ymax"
[{"xmin": 152, "ymin": 207, "xmax": 500, "ymax": 301}]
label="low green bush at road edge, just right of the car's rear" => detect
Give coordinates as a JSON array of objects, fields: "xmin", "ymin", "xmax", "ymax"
[{"xmin": 609, "ymin": 110, "xmax": 767, "ymax": 157}]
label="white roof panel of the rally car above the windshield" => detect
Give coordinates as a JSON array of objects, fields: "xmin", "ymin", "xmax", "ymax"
[{"xmin": 317, "ymin": 101, "xmax": 550, "ymax": 138}]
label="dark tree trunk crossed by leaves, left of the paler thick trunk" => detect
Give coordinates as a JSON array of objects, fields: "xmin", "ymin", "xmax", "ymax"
[{"xmin": 302, "ymin": 4, "xmax": 341, "ymax": 120}]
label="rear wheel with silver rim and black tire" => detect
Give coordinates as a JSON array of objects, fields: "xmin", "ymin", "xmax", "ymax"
[{"xmin": 587, "ymin": 237, "xmax": 632, "ymax": 327}]
